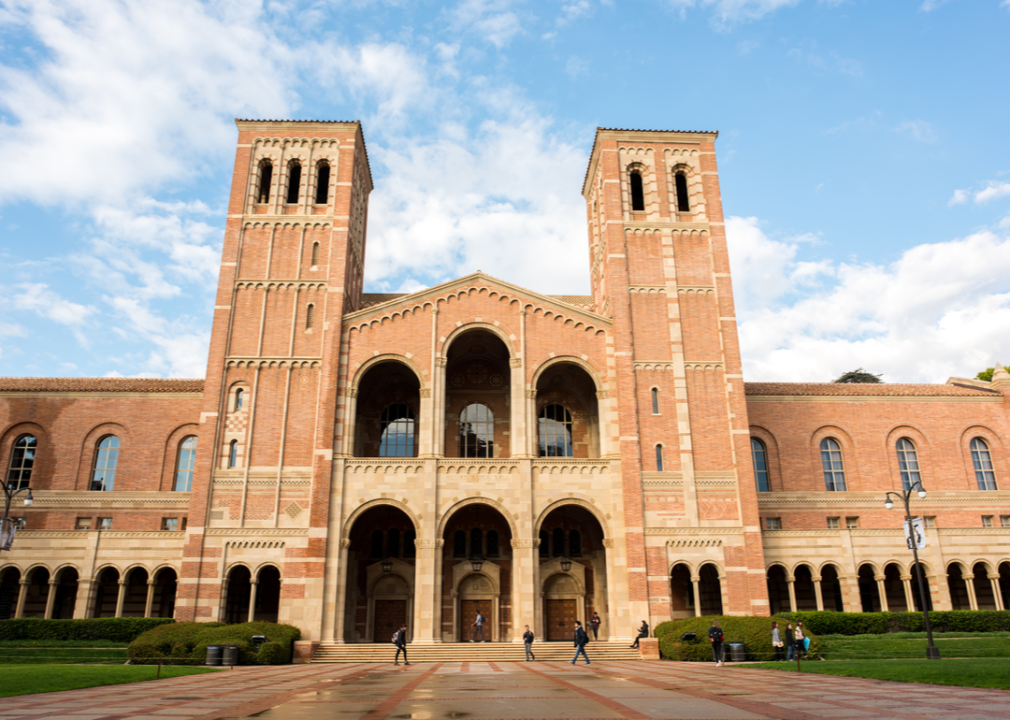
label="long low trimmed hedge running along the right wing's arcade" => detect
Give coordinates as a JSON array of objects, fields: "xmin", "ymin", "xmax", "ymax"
[{"xmin": 780, "ymin": 610, "xmax": 1010, "ymax": 635}]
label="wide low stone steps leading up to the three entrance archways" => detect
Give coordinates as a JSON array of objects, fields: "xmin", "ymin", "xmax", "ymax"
[{"xmin": 312, "ymin": 642, "xmax": 641, "ymax": 662}]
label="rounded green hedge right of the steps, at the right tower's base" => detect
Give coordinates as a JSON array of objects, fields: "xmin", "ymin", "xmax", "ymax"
[{"xmin": 655, "ymin": 615, "xmax": 820, "ymax": 662}]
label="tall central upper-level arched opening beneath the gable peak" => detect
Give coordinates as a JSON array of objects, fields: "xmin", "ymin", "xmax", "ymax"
[{"xmin": 444, "ymin": 329, "xmax": 512, "ymax": 458}]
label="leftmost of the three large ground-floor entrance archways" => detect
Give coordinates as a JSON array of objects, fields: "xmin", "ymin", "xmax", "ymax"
[{"xmin": 344, "ymin": 504, "xmax": 417, "ymax": 642}]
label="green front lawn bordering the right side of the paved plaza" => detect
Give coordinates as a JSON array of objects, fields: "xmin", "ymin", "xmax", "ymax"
[{"xmin": 737, "ymin": 658, "xmax": 1010, "ymax": 690}]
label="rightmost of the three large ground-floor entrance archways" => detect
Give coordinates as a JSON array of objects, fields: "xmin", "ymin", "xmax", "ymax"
[{"xmin": 537, "ymin": 503, "xmax": 610, "ymax": 640}]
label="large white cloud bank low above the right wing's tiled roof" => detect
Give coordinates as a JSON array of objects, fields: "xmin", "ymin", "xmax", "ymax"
[{"xmin": 726, "ymin": 218, "xmax": 1010, "ymax": 382}]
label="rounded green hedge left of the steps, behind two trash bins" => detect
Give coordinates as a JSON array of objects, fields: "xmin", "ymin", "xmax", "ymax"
[{"xmin": 128, "ymin": 622, "xmax": 301, "ymax": 665}]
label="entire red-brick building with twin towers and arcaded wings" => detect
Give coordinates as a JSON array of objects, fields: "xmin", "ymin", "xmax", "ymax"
[{"xmin": 0, "ymin": 120, "xmax": 1010, "ymax": 642}]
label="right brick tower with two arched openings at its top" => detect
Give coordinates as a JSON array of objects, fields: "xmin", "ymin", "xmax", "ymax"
[{"xmin": 583, "ymin": 128, "xmax": 769, "ymax": 622}]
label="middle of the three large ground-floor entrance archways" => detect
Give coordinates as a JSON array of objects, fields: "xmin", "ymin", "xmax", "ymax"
[{"xmin": 441, "ymin": 502, "xmax": 513, "ymax": 641}]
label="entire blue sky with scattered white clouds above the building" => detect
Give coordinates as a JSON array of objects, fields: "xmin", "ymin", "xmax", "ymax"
[{"xmin": 0, "ymin": 0, "xmax": 1010, "ymax": 382}]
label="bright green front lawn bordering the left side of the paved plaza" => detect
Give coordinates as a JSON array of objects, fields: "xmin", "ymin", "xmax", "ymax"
[{"xmin": 0, "ymin": 665, "xmax": 216, "ymax": 698}]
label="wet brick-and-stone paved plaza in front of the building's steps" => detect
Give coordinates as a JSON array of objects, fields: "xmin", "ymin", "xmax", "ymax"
[{"xmin": 0, "ymin": 661, "xmax": 1010, "ymax": 720}]
